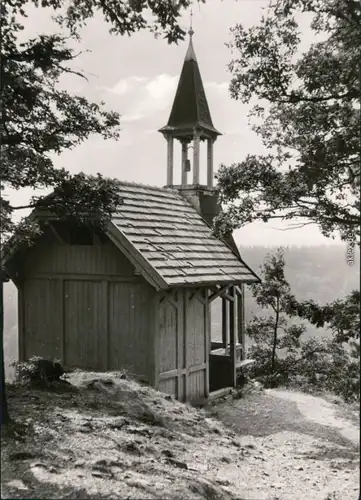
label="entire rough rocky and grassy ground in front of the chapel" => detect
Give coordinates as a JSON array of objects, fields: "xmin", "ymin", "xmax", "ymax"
[{"xmin": 1, "ymin": 372, "xmax": 359, "ymax": 500}]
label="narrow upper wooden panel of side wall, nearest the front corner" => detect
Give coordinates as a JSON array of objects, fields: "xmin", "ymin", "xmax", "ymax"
[{"xmin": 159, "ymin": 298, "xmax": 178, "ymax": 373}]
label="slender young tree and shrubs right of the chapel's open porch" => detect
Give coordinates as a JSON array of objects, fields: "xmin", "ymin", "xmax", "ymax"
[{"xmin": 246, "ymin": 250, "xmax": 360, "ymax": 401}]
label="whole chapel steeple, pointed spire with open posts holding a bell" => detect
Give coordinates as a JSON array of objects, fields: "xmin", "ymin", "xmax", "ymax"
[{"xmin": 159, "ymin": 20, "xmax": 221, "ymax": 188}]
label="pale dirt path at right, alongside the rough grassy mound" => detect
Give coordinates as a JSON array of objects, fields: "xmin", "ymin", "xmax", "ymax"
[{"xmin": 207, "ymin": 389, "xmax": 360, "ymax": 500}]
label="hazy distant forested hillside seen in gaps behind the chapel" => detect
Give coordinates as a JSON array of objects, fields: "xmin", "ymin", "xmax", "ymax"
[{"xmin": 4, "ymin": 245, "xmax": 360, "ymax": 378}]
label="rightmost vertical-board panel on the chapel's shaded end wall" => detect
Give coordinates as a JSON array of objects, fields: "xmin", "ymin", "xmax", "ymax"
[{"xmin": 108, "ymin": 282, "xmax": 154, "ymax": 377}]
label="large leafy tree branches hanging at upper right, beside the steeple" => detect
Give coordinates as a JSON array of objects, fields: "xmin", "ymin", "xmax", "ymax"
[{"xmin": 215, "ymin": 0, "xmax": 361, "ymax": 242}]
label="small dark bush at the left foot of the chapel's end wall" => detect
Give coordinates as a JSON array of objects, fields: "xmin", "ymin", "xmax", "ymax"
[{"xmin": 13, "ymin": 356, "xmax": 65, "ymax": 385}]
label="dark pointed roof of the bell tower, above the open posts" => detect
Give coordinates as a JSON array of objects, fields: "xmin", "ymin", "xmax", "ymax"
[{"xmin": 159, "ymin": 28, "xmax": 221, "ymax": 138}]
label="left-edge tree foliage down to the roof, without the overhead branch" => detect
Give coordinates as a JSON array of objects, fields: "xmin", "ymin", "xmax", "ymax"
[{"xmin": 0, "ymin": 2, "xmax": 121, "ymax": 240}]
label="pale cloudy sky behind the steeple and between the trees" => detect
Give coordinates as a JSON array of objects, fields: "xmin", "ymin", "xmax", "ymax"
[{"xmin": 6, "ymin": 0, "xmax": 340, "ymax": 246}]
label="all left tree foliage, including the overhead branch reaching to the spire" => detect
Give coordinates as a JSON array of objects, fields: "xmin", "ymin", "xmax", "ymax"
[{"xmin": 0, "ymin": 0, "xmax": 197, "ymax": 424}]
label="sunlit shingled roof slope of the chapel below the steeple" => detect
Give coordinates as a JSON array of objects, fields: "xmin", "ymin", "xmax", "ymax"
[{"xmin": 108, "ymin": 182, "xmax": 259, "ymax": 288}]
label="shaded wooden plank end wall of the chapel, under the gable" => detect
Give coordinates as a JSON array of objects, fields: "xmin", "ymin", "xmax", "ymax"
[{"xmin": 19, "ymin": 232, "xmax": 155, "ymax": 379}]
